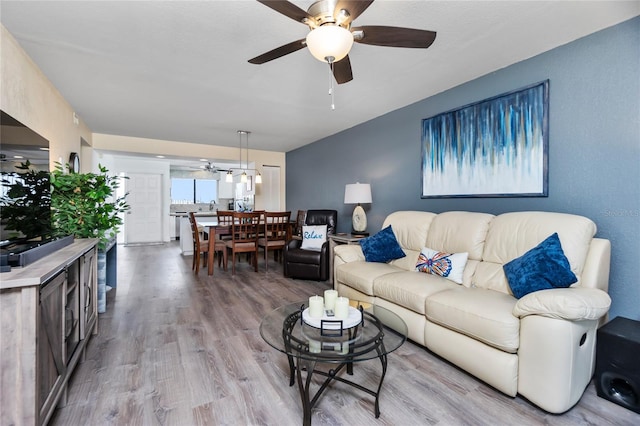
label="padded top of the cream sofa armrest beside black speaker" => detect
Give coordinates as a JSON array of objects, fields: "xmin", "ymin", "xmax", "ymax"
[{"xmin": 512, "ymin": 287, "xmax": 611, "ymax": 321}]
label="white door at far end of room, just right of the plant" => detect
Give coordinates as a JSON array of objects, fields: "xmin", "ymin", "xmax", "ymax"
[{"xmin": 124, "ymin": 173, "xmax": 162, "ymax": 244}]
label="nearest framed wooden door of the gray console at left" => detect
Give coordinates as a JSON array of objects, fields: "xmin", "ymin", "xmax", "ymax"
[{"xmin": 38, "ymin": 271, "xmax": 66, "ymax": 418}]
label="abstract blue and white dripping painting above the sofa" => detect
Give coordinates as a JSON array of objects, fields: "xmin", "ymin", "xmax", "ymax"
[{"xmin": 422, "ymin": 80, "xmax": 549, "ymax": 198}]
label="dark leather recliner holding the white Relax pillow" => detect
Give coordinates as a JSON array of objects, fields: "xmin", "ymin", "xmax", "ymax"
[{"xmin": 284, "ymin": 210, "xmax": 338, "ymax": 281}]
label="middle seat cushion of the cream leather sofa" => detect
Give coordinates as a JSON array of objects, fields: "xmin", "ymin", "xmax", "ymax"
[{"xmin": 373, "ymin": 271, "xmax": 457, "ymax": 315}]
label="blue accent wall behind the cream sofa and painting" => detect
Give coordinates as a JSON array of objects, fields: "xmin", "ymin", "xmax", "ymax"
[{"xmin": 286, "ymin": 18, "xmax": 640, "ymax": 320}]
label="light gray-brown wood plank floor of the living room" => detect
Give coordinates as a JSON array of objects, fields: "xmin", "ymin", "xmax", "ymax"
[{"xmin": 50, "ymin": 242, "xmax": 640, "ymax": 426}]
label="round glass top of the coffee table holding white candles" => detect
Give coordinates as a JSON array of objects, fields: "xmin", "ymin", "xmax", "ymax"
[{"xmin": 260, "ymin": 301, "xmax": 407, "ymax": 363}]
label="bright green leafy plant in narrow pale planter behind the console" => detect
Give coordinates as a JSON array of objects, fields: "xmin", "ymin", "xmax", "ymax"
[{"xmin": 51, "ymin": 162, "xmax": 130, "ymax": 313}]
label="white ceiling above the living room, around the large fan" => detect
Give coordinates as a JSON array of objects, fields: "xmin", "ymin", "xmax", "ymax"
[{"xmin": 0, "ymin": 0, "xmax": 640, "ymax": 152}]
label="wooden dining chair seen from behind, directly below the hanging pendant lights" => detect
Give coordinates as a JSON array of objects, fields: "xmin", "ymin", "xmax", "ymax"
[{"xmin": 225, "ymin": 212, "xmax": 261, "ymax": 275}]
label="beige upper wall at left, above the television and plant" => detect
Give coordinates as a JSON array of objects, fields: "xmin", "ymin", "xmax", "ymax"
[{"xmin": 0, "ymin": 25, "xmax": 92, "ymax": 168}]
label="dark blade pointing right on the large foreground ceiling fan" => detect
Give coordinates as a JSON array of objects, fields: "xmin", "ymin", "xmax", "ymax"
[{"xmin": 351, "ymin": 25, "xmax": 436, "ymax": 49}]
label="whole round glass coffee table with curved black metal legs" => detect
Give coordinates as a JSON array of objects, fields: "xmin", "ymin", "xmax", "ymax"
[{"xmin": 260, "ymin": 301, "xmax": 407, "ymax": 426}]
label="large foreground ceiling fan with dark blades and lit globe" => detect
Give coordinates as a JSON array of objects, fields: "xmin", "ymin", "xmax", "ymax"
[{"xmin": 249, "ymin": 0, "xmax": 436, "ymax": 84}]
